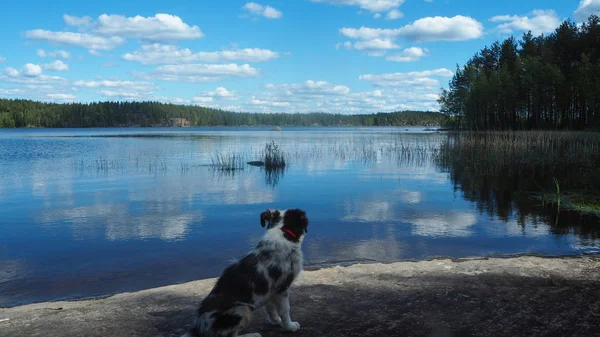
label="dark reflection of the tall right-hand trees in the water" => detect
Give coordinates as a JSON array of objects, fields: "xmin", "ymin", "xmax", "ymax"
[{"xmin": 435, "ymin": 133, "xmax": 600, "ymax": 246}]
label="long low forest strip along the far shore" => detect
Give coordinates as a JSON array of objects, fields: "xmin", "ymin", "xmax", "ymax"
[{"xmin": 0, "ymin": 99, "xmax": 446, "ymax": 128}]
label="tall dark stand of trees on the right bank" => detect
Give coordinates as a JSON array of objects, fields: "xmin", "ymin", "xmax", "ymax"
[{"xmin": 438, "ymin": 15, "xmax": 600, "ymax": 130}]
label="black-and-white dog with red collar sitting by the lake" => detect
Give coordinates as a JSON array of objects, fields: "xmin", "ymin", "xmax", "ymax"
[{"xmin": 183, "ymin": 209, "xmax": 309, "ymax": 337}]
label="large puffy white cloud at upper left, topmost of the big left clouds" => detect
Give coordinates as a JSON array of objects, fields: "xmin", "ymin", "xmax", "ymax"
[{"xmin": 92, "ymin": 13, "xmax": 204, "ymax": 41}]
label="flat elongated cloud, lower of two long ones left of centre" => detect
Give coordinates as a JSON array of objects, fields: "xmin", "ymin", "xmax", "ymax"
[{"xmin": 132, "ymin": 63, "xmax": 260, "ymax": 82}]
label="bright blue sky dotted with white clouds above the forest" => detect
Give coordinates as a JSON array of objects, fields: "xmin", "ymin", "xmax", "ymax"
[{"xmin": 0, "ymin": 0, "xmax": 600, "ymax": 114}]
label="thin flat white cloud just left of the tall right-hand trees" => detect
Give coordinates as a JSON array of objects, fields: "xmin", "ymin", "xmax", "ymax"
[{"xmin": 359, "ymin": 68, "xmax": 453, "ymax": 87}]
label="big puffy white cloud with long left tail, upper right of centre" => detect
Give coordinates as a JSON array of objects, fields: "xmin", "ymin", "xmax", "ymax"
[{"xmin": 340, "ymin": 15, "xmax": 483, "ymax": 42}]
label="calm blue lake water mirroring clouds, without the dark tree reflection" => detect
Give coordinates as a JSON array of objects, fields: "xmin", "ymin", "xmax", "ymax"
[{"xmin": 0, "ymin": 128, "xmax": 600, "ymax": 307}]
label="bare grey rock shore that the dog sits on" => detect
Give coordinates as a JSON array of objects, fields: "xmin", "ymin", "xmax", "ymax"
[{"xmin": 0, "ymin": 256, "xmax": 600, "ymax": 337}]
